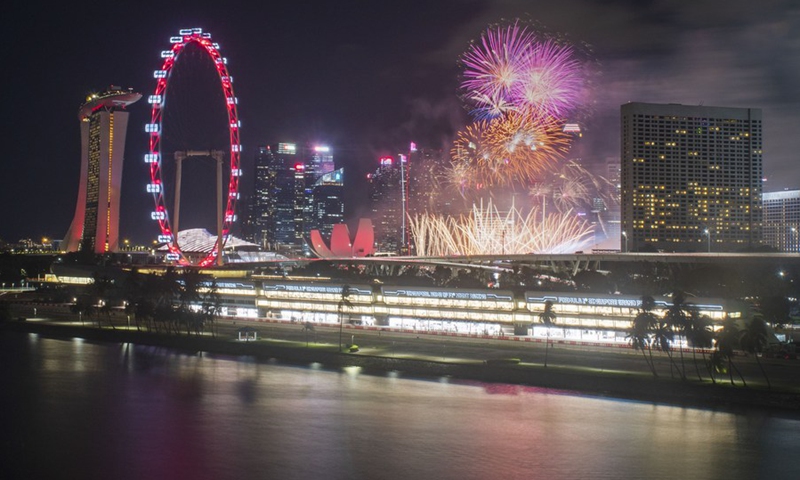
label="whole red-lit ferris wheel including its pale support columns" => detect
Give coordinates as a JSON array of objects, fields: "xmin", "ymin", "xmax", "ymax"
[{"xmin": 144, "ymin": 28, "xmax": 242, "ymax": 267}]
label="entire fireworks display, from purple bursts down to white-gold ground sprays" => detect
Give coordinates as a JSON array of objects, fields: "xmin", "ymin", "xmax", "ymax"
[{"xmin": 409, "ymin": 22, "xmax": 613, "ymax": 256}]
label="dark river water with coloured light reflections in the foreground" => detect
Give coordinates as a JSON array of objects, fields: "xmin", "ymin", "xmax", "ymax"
[{"xmin": 0, "ymin": 333, "xmax": 800, "ymax": 480}]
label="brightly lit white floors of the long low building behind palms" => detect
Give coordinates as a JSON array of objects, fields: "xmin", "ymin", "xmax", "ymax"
[{"xmin": 255, "ymin": 279, "xmax": 746, "ymax": 347}]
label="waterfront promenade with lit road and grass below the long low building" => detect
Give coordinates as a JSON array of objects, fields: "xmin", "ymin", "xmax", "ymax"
[{"xmin": 0, "ymin": 305, "xmax": 800, "ymax": 414}]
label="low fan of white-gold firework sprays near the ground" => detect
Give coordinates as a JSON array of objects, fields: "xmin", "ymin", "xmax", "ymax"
[{"xmin": 409, "ymin": 202, "xmax": 592, "ymax": 257}]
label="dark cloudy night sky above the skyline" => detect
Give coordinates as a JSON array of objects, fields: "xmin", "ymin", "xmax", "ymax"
[{"xmin": 0, "ymin": 0, "xmax": 800, "ymax": 242}]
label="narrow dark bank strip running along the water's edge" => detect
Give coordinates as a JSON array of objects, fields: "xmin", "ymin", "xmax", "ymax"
[{"xmin": 0, "ymin": 321, "xmax": 800, "ymax": 417}]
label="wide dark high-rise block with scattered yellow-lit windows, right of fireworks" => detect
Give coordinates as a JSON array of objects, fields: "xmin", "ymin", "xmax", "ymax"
[{"xmin": 620, "ymin": 103, "xmax": 762, "ymax": 252}]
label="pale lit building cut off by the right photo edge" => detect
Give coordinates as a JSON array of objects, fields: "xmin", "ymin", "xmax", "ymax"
[{"xmin": 762, "ymin": 190, "xmax": 800, "ymax": 253}]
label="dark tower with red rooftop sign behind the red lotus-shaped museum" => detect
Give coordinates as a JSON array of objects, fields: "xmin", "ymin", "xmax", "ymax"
[{"xmin": 367, "ymin": 156, "xmax": 403, "ymax": 254}]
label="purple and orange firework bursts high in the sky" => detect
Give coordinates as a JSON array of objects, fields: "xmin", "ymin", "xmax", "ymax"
[{"xmin": 447, "ymin": 18, "xmax": 585, "ymax": 197}]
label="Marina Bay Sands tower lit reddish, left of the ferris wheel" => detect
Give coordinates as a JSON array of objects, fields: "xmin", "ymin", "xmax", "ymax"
[{"xmin": 62, "ymin": 86, "xmax": 142, "ymax": 253}]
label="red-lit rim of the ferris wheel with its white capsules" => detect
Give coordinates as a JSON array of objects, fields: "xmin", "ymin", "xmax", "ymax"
[{"xmin": 145, "ymin": 28, "xmax": 241, "ymax": 266}]
